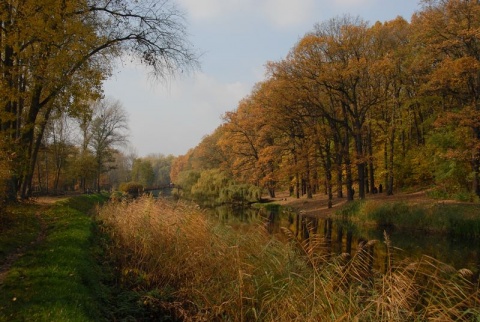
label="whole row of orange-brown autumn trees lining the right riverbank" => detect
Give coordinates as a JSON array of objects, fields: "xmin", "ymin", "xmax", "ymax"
[{"xmin": 172, "ymin": 0, "xmax": 480, "ymax": 205}]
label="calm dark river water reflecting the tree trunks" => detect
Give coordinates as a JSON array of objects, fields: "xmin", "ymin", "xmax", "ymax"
[{"xmin": 209, "ymin": 207, "xmax": 480, "ymax": 274}]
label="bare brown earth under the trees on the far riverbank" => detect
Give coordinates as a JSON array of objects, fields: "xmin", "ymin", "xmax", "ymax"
[{"xmin": 270, "ymin": 191, "xmax": 455, "ymax": 217}]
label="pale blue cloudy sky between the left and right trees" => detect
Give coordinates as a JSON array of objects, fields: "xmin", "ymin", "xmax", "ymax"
[{"xmin": 104, "ymin": 0, "xmax": 421, "ymax": 157}]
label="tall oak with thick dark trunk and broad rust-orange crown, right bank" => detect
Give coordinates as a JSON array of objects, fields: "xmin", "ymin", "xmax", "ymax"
[{"xmin": 315, "ymin": 16, "xmax": 381, "ymax": 199}]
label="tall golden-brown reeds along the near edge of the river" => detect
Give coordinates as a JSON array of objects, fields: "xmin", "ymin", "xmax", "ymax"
[{"xmin": 97, "ymin": 198, "xmax": 480, "ymax": 321}]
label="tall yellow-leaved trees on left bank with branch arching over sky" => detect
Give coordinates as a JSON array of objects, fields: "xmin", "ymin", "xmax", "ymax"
[{"xmin": 0, "ymin": 0, "xmax": 197, "ymax": 199}]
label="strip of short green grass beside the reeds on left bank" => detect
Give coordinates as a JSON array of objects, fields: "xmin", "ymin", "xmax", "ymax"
[{"xmin": 0, "ymin": 196, "xmax": 106, "ymax": 321}]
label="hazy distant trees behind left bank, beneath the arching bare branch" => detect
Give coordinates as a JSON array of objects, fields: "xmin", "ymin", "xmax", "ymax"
[{"xmin": 32, "ymin": 104, "xmax": 174, "ymax": 195}]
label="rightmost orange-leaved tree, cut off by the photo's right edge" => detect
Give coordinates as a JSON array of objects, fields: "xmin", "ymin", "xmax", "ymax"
[{"xmin": 412, "ymin": 0, "xmax": 480, "ymax": 196}]
